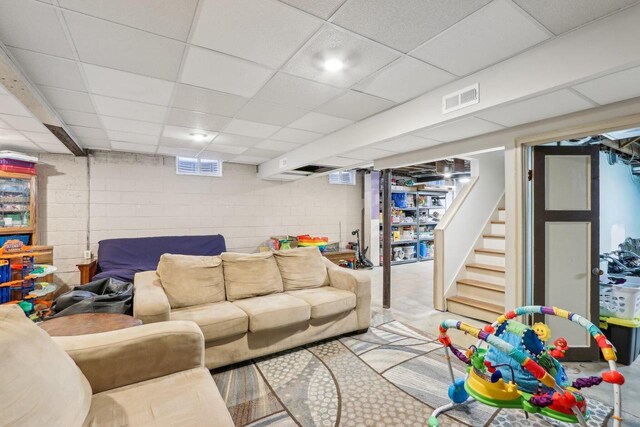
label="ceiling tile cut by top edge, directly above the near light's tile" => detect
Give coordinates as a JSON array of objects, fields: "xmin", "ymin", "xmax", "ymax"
[{"xmin": 332, "ymin": 0, "xmax": 490, "ymax": 52}]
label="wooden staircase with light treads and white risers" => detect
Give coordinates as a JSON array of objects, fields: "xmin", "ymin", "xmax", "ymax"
[{"xmin": 447, "ymin": 209, "xmax": 505, "ymax": 322}]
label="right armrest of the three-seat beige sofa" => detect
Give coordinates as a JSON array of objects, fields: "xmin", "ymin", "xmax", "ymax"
[{"xmin": 323, "ymin": 258, "xmax": 371, "ymax": 330}]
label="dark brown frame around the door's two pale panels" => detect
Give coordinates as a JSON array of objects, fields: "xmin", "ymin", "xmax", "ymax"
[{"xmin": 530, "ymin": 146, "xmax": 600, "ymax": 361}]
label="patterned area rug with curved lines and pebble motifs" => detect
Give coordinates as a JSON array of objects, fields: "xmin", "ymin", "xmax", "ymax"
[{"xmin": 212, "ymin": 321, "xmax": 612, "ymax": 427}]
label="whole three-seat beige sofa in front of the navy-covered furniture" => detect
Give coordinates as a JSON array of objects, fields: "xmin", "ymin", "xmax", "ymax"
[{"xmin": 134, "ymin": 248, "xmax": 371, "ymax": 369}]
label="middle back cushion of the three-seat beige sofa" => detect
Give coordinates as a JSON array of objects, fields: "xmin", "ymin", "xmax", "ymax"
[{"xmin": 222, "ymin": 252, "xmax": 283, "ymax": 301}]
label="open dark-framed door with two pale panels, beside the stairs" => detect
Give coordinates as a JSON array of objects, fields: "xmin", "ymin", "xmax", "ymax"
[{"xmin": 533, "ymin": 146, "xmax": 600, "ymax": 360}]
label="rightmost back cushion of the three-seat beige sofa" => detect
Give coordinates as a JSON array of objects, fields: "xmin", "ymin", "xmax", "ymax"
[{"xmin": 274, "ymin": 246, "xmax": 329, "ymax": 291}]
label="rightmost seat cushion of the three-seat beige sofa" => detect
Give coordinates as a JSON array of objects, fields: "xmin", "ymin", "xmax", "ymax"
[{"xmin": 287, "ymin": 286, "xmax": 356, "ymax": 319}]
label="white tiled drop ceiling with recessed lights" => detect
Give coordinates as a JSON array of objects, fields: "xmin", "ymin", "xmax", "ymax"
[{"xmin": 0, "ymin": 0, "xmax": 640, "ymax": 171}]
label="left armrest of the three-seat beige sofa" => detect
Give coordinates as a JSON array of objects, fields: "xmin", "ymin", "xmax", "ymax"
[{"xmin": 133, "ymin": 271, "xmax": 171, "ymax": 323}]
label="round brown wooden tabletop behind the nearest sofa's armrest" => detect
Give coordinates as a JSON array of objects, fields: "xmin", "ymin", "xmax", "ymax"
[{"xmin": 39, "ymin": 313, "xmax": 142, "ymax": 337}]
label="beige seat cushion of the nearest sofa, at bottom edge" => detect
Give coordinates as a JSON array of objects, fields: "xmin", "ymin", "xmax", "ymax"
[{"xmin": 84, "ymin": 368, "xmax": 233, "ymax": 427}]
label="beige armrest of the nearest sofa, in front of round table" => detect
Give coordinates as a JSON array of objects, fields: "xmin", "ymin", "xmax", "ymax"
[{"xmin": 52, "ymin": 320, "xmax": 204, "ymax": 394}]
